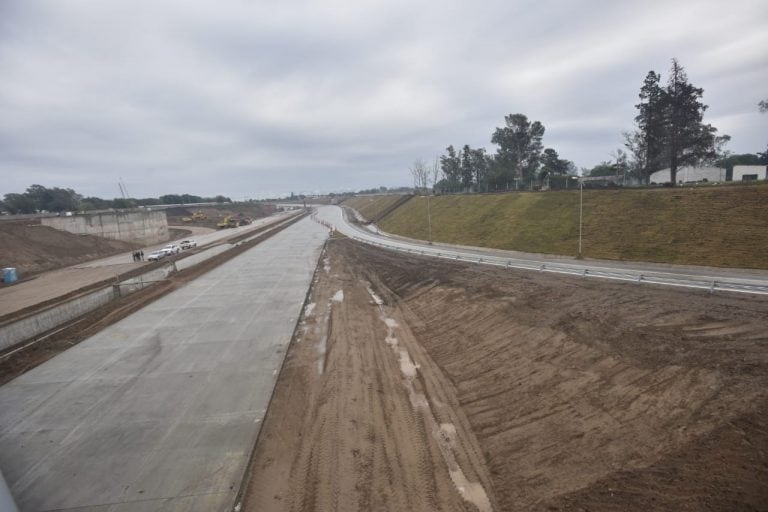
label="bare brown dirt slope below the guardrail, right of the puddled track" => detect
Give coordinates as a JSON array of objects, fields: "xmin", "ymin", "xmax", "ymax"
[{"xmin": 346, "ymin": 240, "xmax": 768, "ymax": 511}]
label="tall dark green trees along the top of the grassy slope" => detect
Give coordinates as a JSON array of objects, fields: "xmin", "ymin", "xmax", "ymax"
[{"xmin": 424, "ymin": 59, "xmax": 768, "ymax": 192}]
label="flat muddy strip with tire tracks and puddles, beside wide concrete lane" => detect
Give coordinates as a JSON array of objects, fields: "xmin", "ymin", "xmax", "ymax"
[{"xmin": 243, "ymin": 242, "xmax": 491, "ymax": 512}]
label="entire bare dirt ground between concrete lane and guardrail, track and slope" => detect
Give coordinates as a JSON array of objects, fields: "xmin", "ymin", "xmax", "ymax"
[{"xmin": 245, "ymin": 240, "xmax": 768, "ymax": 511}]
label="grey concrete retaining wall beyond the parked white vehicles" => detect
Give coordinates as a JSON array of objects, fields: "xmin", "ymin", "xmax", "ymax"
[{"xmin": 40, "ymin": 211, "xmax": 168, "ymax": 245}]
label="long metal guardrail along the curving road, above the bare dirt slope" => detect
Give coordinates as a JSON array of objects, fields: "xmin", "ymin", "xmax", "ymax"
[{"xmin": 350, "ymin": 233, "xmax": 768, "ymax": 295}]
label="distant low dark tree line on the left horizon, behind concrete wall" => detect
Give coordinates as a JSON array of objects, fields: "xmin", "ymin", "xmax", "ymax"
[{"xmin": 0, "ymin": 185, "xmax": 231, "ymax": 214}]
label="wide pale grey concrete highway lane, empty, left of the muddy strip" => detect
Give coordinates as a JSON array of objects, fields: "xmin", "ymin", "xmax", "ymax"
[{"xmin": 0, "ymin": 219, "xmax": 327, "ymax": 512}]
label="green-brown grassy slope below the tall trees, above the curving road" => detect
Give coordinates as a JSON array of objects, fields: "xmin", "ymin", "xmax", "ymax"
[{"xmin": 380, "ymin": 186, "xmax": 768, "ymax": 268}]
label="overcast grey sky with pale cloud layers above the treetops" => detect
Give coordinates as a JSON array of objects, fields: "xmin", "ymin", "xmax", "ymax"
[{"xmin": 0, "ymin": 0, "xmax": 768, "ymax": 199}]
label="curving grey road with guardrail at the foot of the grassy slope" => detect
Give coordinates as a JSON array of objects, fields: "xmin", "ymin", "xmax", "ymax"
[{"xmin": 317, "ymin": 206, "xmax": 768, "ymax": 295}]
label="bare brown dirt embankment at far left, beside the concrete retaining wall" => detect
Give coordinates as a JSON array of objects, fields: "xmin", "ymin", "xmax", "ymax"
[{"xmin": 0, "ymin": 220, "xmax": 140, "ymax": 278}]
